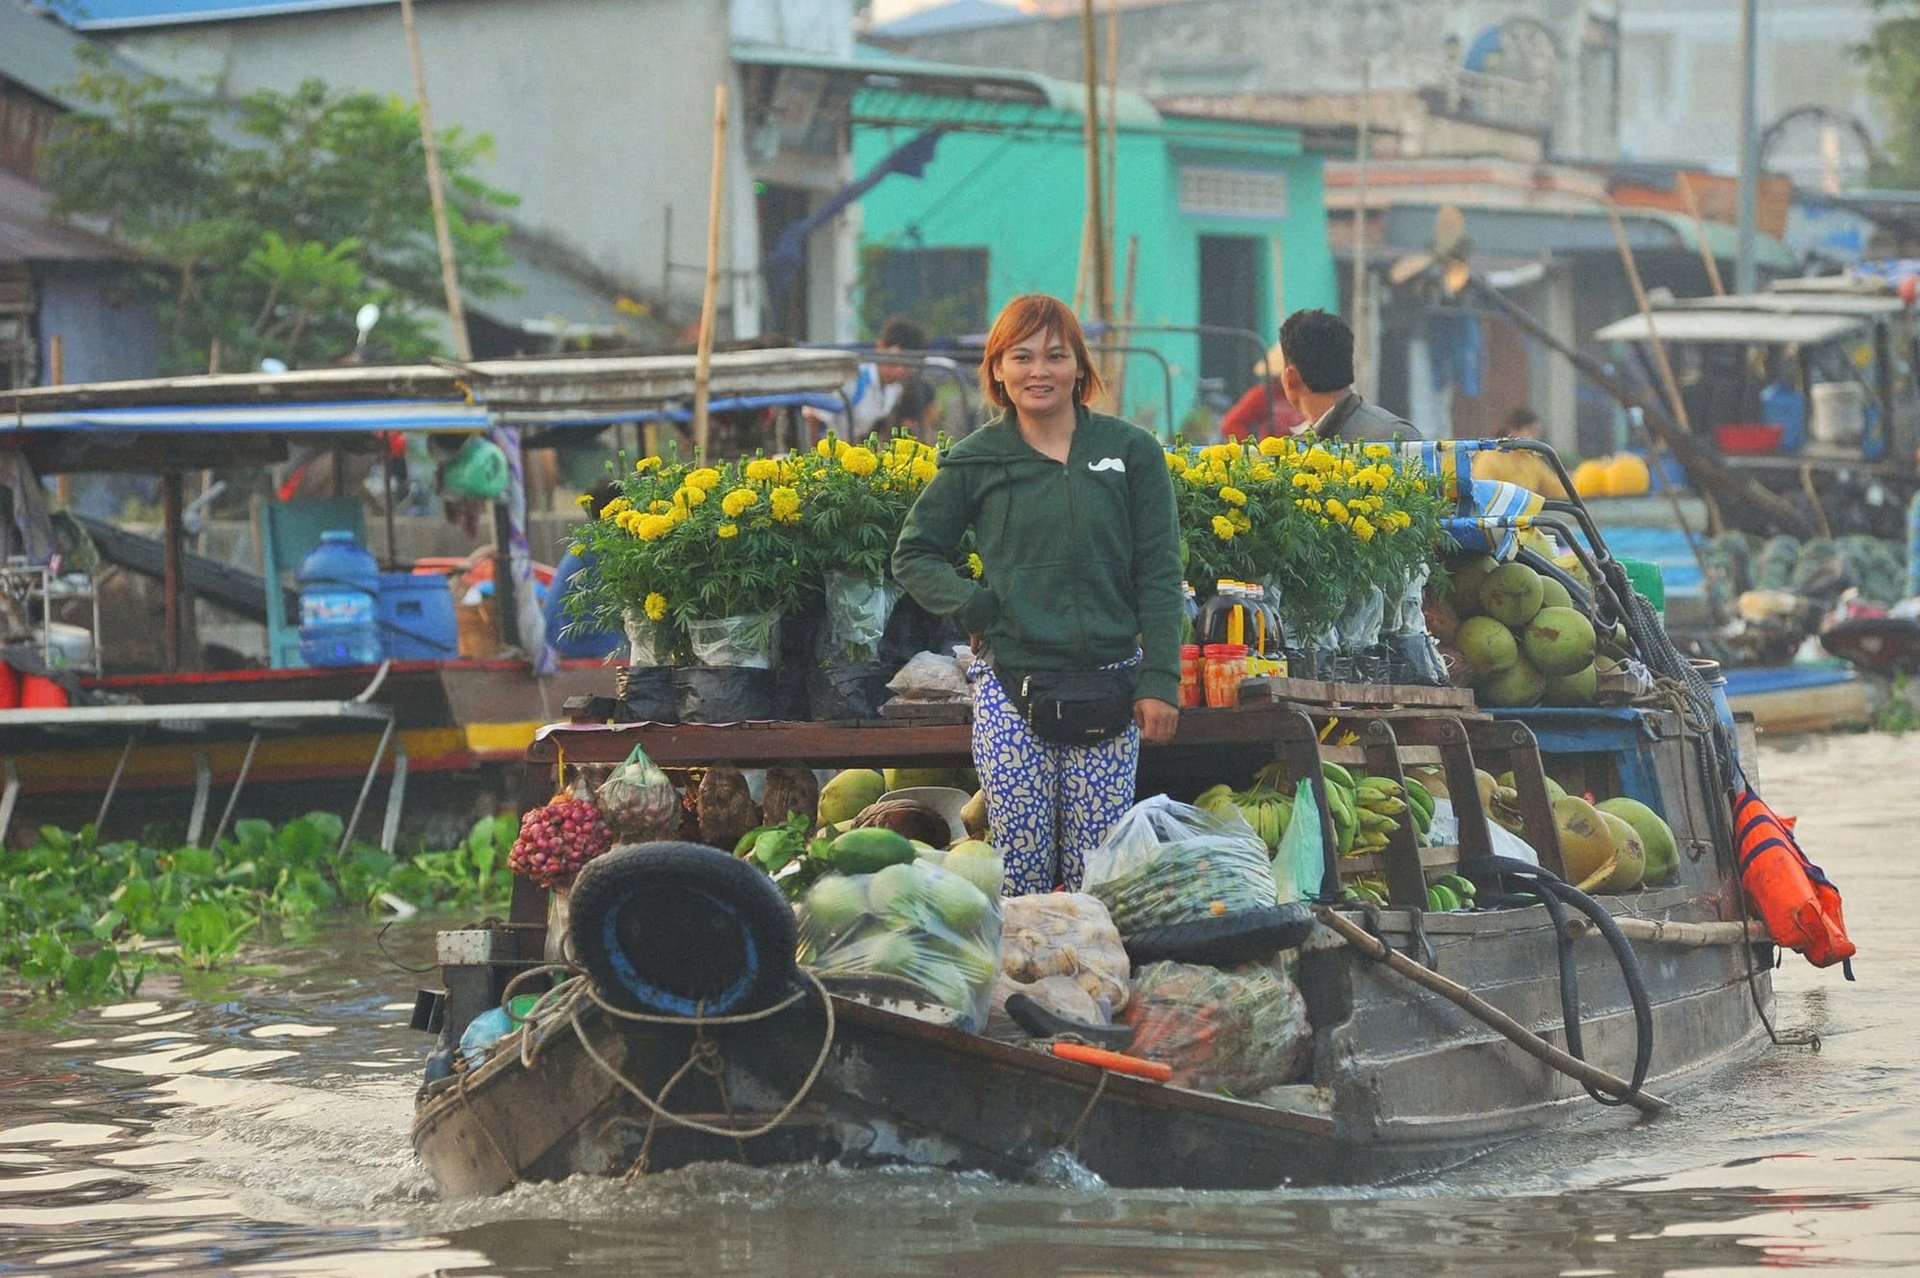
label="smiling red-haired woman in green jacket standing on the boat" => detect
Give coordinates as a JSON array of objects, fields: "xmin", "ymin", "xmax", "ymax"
[{"xmin": 893, "ymin": 294, "xmax": 1183, "ymax": 892}]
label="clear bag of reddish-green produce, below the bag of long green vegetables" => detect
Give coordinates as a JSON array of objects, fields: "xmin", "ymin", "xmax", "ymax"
[{"xmin": 1121, "ymin": 961, "xmax": 1313, "ymax": 1096}]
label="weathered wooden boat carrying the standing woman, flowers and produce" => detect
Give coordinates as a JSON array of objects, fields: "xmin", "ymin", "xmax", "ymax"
[{"xmin": 413, "ymin": 687, "xmax": 1772, "ymax": 1195}]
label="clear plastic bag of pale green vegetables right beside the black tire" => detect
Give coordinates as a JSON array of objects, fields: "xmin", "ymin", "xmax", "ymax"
[{"xmin": 795, "ymin": 862, "xmax": 1000, "ymax": 1032}]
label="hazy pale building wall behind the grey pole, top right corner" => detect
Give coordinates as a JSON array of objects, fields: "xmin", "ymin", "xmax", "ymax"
[{"xmin": 1620, "ymin": 0, "xmax": 1885, "ymax": 188}]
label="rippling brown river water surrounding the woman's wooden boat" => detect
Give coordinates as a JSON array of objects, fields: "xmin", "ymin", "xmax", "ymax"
[{"xmin": 0, "ymin": 735, "xmax": 1920, "ymax": 1278}]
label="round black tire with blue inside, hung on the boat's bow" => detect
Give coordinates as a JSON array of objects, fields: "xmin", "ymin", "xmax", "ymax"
[{"xmin": 566, "ymin": 842, "xmax": 797, "ymax": 1017}]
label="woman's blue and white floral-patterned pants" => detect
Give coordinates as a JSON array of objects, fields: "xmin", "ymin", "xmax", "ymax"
[{"xmin": 968, "ymin": 658, "xmax": 1140, "ymax": 896}]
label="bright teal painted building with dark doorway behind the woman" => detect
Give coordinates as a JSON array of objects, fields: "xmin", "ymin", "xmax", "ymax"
[{"xmin": 852, "ymin": 73, "xmax": 1340, "ymax": 432}]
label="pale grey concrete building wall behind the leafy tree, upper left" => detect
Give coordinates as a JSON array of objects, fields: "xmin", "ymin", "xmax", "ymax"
[{"xmin": 103, "ymin": 0, "xmax": 748, "ymax": 332}]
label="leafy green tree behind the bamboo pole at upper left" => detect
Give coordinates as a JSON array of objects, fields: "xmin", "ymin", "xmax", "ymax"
[{"xmin": 46, "ymin": 56, "xmax": 518, "ymax": 372}]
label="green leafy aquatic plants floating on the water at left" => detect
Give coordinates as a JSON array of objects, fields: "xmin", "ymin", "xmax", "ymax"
[{"xmin": 0, "ymin": 812, "xmax": 516, "ymax": 1002}]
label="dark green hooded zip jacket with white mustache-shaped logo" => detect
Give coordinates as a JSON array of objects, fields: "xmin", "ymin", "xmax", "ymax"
[{"xmin": 893, "ymin": 407, "xmax": 1185, "ymax": 704}]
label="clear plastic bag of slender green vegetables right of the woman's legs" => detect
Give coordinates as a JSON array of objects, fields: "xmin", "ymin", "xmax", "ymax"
[{"xmin": 1085, "ymin": 794, "xmax": 1275, "ymax": 936}]
